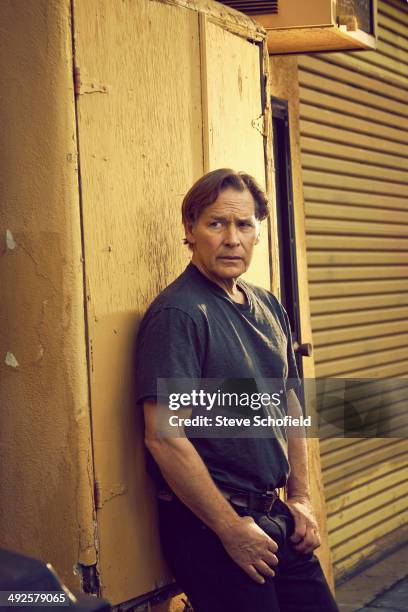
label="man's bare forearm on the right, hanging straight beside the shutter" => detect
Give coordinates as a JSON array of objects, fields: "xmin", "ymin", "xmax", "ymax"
[{"xmin": 287, "ymin": 391, "xmax": 310, "ymax": 499}]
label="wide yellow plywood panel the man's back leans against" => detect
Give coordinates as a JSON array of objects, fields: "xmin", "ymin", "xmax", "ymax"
[{"xmin": 74, "ymin": 0, "xmax": 203, "ymax": 603}]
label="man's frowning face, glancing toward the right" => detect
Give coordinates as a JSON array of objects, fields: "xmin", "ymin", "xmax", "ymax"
[{"xmin": 186, "ymin": 187, "xmax": 260, "ymax": 282}]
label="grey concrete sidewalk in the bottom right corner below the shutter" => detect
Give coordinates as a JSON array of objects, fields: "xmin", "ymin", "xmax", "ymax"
[{"xmin": 336, "ymin": 546, "xmax": 408, "ymax": 612}]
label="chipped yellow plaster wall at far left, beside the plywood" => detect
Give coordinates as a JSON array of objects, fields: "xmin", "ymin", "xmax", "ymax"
[{"xmin": 0, "ymin": 0, "xmax": 95, "ymax": 585}]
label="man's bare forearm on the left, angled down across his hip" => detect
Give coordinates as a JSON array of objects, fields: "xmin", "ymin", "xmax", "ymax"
[{"xmin": 146, "ymin": 438, "xmax": 239, "ymax": 533}]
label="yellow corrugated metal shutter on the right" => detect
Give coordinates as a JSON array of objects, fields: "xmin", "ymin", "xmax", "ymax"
[{"xmin": 299, "ymin": 0, "xmax": 408, "ymax": 579}]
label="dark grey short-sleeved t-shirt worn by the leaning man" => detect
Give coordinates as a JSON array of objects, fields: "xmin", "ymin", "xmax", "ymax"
[{"xmin": 136, "ymin": 263, "xmax": 299, "ymax": 492}]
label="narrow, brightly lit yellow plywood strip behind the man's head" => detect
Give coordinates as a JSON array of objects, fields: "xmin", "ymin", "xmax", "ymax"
[{"xmin": 202, "ymin": 20, "xmax": 271, "ymax": 289}]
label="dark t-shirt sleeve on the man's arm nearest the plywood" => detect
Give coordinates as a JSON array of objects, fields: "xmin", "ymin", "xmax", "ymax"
[{"xmin": 135, "ymin": 308, "xmax": 203, "ymax": 403}]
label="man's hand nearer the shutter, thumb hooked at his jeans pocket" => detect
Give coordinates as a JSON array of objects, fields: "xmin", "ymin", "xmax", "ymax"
[{"xmin": 286, "ymin": 497, "xmax": 320, "ymax": 554}]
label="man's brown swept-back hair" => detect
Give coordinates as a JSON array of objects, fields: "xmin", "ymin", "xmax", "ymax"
[{"xmin": 181, "ymin": 168, "xmax": 269, "ymax": 230}]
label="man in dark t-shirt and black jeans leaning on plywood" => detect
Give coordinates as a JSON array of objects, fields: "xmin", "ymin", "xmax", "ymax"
[{"xmin": 136, "ymin": 169, "xmax": 337, "ymax": 612}]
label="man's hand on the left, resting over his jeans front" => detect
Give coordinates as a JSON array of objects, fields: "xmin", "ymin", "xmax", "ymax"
[{"xmin": 218, "ymin": 516, "xmax": 278, "ymax": 584}]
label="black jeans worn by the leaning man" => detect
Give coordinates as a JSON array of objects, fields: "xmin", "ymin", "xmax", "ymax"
[{"xmin": 159, "ymin": 498, "xmax": 338, "ymax": 612}]
